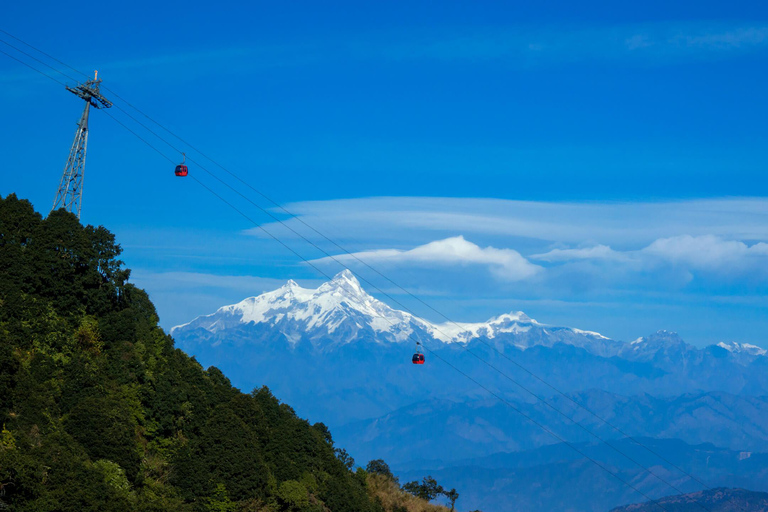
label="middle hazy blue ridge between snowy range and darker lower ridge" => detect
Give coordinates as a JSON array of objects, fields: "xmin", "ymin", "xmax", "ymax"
[{"xmin": 334, "ymin": 390, "xmax": 768, "ymax": 467}]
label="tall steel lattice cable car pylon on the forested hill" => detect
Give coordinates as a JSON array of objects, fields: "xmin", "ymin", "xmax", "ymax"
[{"xmin": 51, "ymin": 74, "xmax": 112, "ymax": 219}]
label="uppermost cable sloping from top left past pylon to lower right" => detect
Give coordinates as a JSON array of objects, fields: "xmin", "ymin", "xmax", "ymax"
[{"xmin": 0, "ymin": 35, "xmax": 724, "ymax": 496}]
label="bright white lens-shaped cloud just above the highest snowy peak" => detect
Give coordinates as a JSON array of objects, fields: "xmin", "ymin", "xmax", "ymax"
[{"xmin": 313, "ymin": 236, "xmax": 542, "ymax": 281}]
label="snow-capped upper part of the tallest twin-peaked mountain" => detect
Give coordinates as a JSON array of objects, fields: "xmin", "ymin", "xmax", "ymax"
[{"xmin": 171, "ymin": 270, "xmax": 623, "ymax": 355}]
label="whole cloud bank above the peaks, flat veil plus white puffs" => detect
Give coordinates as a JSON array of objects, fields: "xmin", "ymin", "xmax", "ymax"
[{"xmin": 269, "ymin": 198, "xmax": 768, "ymax": 295}]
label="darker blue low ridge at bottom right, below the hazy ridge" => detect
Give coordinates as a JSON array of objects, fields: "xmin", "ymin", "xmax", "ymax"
[{"xmin": 395, "ymin": 438, "xmax": 768, "ymax": 512}]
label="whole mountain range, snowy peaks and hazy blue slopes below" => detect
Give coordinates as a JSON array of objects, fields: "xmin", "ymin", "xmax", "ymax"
[{"xmin": 171, "ymin": 270, "xmax": 768, "ymax": 510}]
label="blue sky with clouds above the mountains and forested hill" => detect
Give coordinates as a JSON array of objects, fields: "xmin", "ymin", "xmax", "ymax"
[{"xmin": 0, "ymin": 2, "xmax": 768, "ymax": 346}]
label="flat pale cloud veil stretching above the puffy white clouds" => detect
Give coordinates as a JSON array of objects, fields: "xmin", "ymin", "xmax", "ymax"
[{"xmin": 247, "ymin": 197, "xmax": 768, "ymax": 248}]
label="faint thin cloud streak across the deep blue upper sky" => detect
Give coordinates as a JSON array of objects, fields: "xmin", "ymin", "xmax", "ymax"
[{"xmin": 6, "ymin": 22, "xmax": 768, "ymax": 82}]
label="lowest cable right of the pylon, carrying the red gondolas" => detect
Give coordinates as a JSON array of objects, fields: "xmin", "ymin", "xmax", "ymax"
[{"xmin": 96, "ymin": 106, "xmax": 672, "ymax": 512}]
